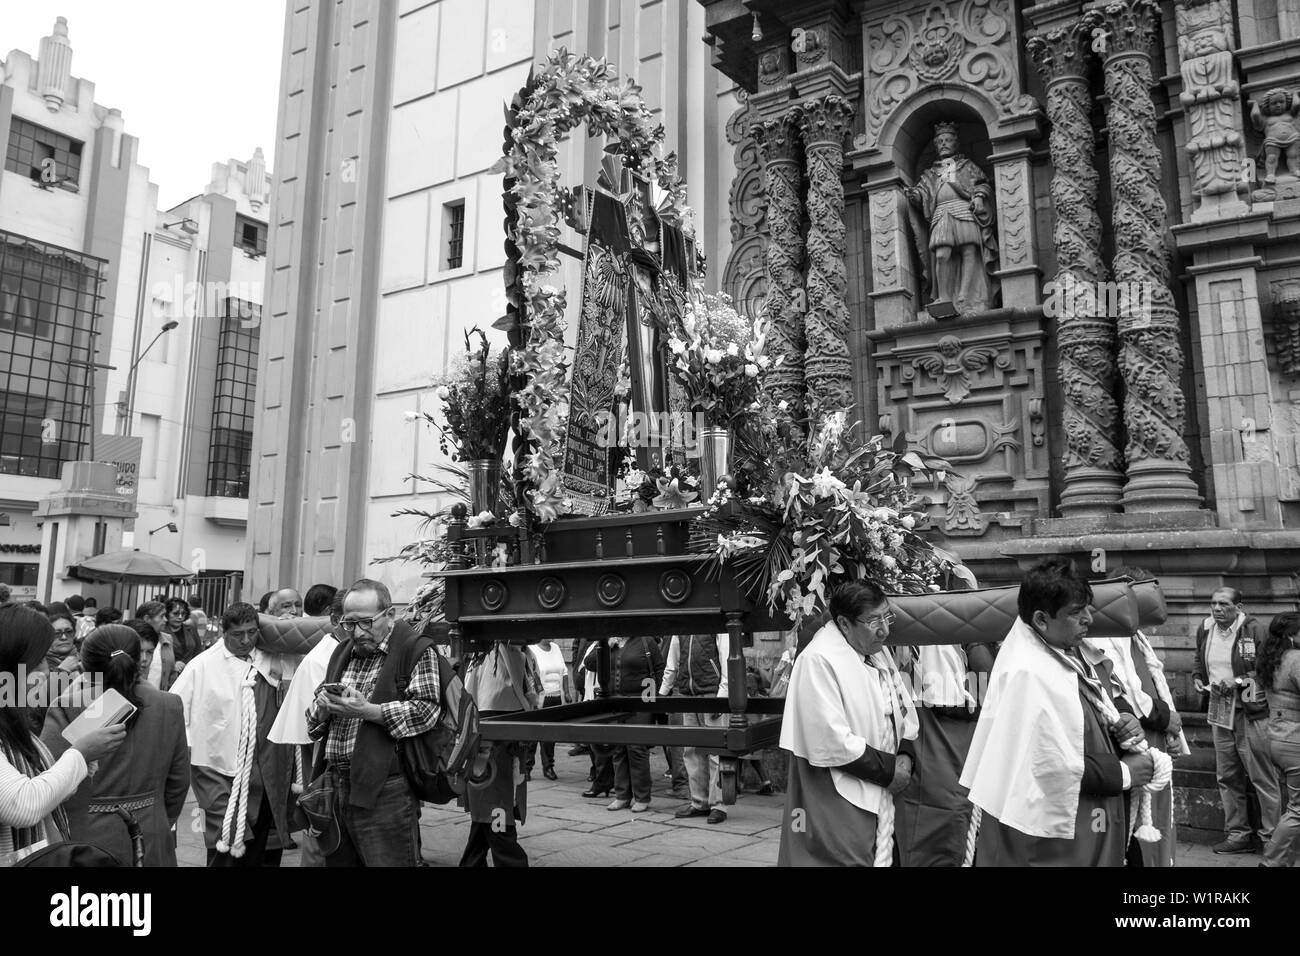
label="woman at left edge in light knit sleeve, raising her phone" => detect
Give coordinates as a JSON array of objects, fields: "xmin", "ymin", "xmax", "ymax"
[{"xmin": 0, "ymin": 606, "xmax": 126, "ymax": 866}]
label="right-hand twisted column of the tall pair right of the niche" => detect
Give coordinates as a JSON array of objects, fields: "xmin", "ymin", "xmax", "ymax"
[{"xmin": 1084, "ymin": 0, "xmax": 1201, "ymax": 512}]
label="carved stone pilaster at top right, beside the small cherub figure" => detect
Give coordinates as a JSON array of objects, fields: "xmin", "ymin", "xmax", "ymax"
[{"xmin": 1175, "ymin": 0, "xmax": 1249, "ymax": 222}]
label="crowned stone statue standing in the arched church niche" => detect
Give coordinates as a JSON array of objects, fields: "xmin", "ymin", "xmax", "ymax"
[{"xmin": 904, "ymin": 122, "xmax": 997, "ymax": 316}]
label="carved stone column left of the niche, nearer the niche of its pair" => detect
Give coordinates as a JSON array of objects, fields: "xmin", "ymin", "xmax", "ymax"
[{"xmin": 797, "ymin": 95, "xmax": 853, "ymax": 419}]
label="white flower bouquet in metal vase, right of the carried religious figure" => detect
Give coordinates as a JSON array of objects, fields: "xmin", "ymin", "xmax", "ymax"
[{"xmin": 668, "ymin": 293, "xmax": 771, "ymax": 428}]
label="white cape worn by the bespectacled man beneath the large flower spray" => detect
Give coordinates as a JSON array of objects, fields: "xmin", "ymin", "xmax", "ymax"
[{"xmin": 780, "ymin": 623, "xmax": 920, "ymax": 814}]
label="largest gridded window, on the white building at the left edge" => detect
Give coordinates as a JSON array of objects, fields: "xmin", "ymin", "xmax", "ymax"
[{"xmin": 0, "ymin": 232, "xmax": 105, "ymax": 479}]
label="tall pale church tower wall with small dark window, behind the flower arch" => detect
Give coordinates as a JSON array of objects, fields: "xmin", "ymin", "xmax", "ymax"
[{"xmin": 248, "ymin": 0, "xmax": 737, "ymax": 601}]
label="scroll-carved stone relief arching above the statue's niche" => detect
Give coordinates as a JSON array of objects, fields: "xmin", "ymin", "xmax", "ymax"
[{"xmin": 861, "ymin": 0, "xmax": 1037, "ymax": 148}]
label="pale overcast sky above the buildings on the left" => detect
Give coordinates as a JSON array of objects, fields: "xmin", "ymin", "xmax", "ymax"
[{"xmin": 0, "ymin": 0, "xmax": 285, "ymax": 209}]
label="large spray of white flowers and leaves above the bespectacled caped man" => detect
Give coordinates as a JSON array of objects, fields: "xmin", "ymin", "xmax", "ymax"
[{"xmin": 692, "ymin": 399, "xmax": 957, "ymax": 628}]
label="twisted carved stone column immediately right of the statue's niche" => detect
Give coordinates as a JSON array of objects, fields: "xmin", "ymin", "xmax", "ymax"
[{"xmin": 1027, "ymin": 22, "xmax": 1123, "ymax": 518}]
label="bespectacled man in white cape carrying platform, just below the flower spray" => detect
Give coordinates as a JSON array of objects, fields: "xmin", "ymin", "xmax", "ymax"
[{"xmin": 777, "ymin": 581, "xmax": 919, "ymax": 866}]
